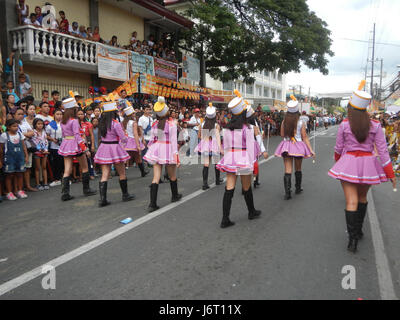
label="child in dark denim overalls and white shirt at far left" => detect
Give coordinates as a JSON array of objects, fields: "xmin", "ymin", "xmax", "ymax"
[{"xmin": 0, "ymin": 119, "xmax": 28, "ymax": 201}]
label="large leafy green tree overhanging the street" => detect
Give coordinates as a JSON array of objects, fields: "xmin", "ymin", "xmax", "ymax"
[{"xmin": 181, "ymin": 0, "xmax": 333, "ymax": 83}]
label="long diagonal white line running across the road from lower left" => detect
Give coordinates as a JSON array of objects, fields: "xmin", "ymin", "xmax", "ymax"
[{"xmin": 0, "ymin": 156, "xmax": 275, "ymax": 296}]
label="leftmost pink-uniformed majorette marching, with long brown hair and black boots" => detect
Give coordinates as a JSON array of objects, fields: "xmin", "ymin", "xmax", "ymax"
[{"xmin": 58, "ymin": 97, "xmax": 97, "ymax": 201}]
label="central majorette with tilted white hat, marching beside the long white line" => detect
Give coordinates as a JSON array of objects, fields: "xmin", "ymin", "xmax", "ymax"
[{"xmin": 217, "ymin": 90, "xmax": 261, "ymax": 228}]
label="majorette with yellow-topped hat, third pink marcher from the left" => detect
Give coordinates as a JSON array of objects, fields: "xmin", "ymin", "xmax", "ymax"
[{"xmin": 143, "ymin": 97, "xmax": 182, "ymax": 212}]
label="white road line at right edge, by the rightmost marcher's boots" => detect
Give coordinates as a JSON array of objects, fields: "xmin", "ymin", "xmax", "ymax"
[{"xmin": 368, "ymin": 190, "xmax": 398, "ymax": 300}]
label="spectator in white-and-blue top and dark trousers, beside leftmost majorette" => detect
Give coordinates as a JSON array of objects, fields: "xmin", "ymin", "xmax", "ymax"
[{"xmin": 46, "ymin": 109, "xmax": 64, "ymax": 187}]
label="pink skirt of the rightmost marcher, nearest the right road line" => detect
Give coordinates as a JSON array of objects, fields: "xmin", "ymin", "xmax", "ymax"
[{"xmin": 328, "ymin": 154, "xmax": 388, "ymax": 184}]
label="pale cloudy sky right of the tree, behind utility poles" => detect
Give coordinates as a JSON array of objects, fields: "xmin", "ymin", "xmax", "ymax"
[{"xmin": 287, "ymin": 0, "xmax": 400, "ymax": 94}]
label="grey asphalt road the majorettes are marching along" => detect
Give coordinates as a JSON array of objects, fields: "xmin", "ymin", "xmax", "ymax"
[{"xmin": 0, "ymin": 127, "xmax": 400, "ymax": 300}]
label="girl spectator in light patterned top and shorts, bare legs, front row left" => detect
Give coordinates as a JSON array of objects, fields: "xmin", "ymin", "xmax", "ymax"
[{"xmin": 32, "ymin": 117, "xmax": 50, "ymax": 191}]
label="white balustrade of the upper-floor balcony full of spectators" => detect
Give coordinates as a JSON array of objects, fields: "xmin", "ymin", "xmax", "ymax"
[{"xmin": 10, "ymin": 26, "xmax": 97, "ymax": 73}]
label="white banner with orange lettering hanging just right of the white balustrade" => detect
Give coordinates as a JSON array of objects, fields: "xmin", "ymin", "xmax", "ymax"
[{"xmin": 97, "ymin": 43, "xmax": 129, "ymax": 81}]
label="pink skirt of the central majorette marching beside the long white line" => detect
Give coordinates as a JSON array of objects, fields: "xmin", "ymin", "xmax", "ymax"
[{"xmin": 217, "ymin": 150, "xmax": 257, "ymax": 175}]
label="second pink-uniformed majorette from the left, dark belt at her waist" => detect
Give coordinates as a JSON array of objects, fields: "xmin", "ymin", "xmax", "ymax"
[{"xmin": 94, "ymin": 101, "xmax": 135, "ymax": 207}]
